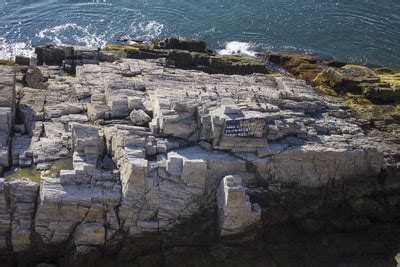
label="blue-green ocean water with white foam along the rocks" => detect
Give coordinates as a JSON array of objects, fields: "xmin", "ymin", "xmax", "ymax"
[{"xmin": 0, "ymin": 0, "xmax": 400, "ymax": 68}]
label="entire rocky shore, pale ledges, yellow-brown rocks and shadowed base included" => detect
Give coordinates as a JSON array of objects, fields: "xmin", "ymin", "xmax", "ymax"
[{"xmin": 0, "ymin": 38, "xmax": 400, "ymax": 266}]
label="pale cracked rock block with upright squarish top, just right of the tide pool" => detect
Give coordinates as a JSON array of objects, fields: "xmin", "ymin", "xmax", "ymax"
[{"xmin": 35, "ymin": 124, "xmax": 121, "ymax": 249}]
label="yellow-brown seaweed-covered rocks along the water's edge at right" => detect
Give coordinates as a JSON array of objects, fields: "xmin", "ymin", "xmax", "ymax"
[{"xmin": 264, "ymin": 52, "xmax": 400, "ymax": 178}]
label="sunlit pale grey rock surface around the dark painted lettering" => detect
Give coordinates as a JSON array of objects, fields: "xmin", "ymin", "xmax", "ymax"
[{"xmin": 0, "ymin": 55, "xmax": 400, "ymax": 260}]
